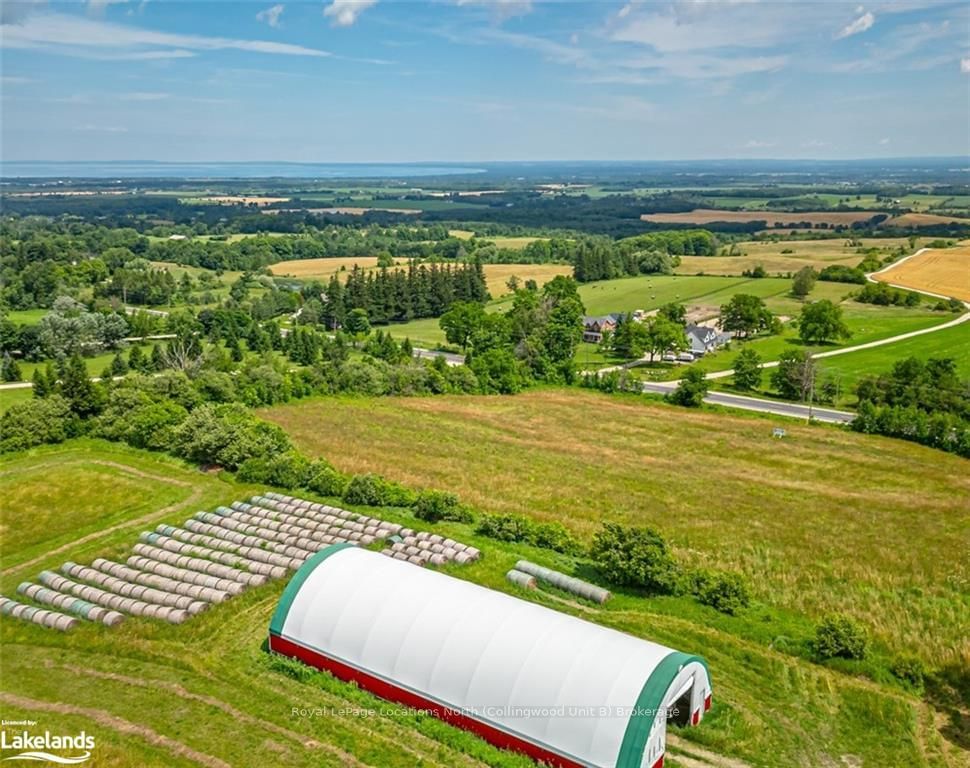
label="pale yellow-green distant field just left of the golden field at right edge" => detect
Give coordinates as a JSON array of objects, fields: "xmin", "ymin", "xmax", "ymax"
[{"xmin": 676, "ymin": 237, "xmax": 919, "ymax": 275}]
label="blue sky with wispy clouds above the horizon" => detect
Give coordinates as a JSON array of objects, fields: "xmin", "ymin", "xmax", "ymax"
[{"xmin": 0, "ymin": 0, "xmax": 970, "ymax": 162}]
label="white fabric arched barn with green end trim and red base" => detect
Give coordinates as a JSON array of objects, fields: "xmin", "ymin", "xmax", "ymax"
[{"xmin": 269, "ymin": 544, "xmax": 711, "ymax": 768}]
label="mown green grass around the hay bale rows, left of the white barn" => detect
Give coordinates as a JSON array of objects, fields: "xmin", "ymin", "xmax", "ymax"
[{"xmin": 0, "ymin": 440, "xmax": 532, "ymax": 768}]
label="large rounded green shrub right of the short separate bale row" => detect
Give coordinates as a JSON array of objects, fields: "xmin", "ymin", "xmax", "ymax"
[{"xmin": 590, "ymin": 523, "xmax": 680, "ymax": 594}]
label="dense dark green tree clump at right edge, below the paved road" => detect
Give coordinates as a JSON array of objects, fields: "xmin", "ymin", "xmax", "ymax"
[{"xmin": 851, "ymin": 357, "xmax": 970, "ymax": 458}]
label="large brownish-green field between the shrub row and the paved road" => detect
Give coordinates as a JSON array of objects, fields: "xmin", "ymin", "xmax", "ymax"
[{"xmin": 263, "ymin": 390, "xmax": 970, "ymax": 664}]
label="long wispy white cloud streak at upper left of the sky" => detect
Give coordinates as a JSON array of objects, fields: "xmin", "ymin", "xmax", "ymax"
[{"xmin": 0, "ymin": 13, "xmax": 332, "ymax": 59}]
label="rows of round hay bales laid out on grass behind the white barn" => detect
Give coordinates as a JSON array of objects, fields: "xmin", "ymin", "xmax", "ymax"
[{"xmin": 0, "ymin": 493, "xmax": 480, "ymax": 630}]
